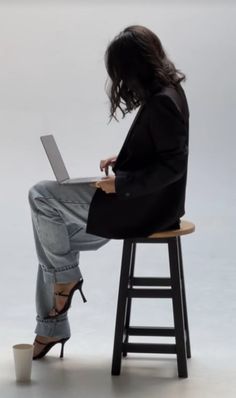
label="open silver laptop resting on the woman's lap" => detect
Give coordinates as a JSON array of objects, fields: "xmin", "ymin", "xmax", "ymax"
[{"xmin": 40, "ymin": 134, "xmax": 99, "ymax": 184}]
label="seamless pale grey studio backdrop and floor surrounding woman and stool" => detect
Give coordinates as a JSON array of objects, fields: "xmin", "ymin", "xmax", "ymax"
[{"xmin": 0, "ymin": 0, "xmax": 236, "ymax": 398}]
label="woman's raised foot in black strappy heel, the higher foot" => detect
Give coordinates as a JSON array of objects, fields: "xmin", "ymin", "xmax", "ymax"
[{"xmin": 48, "ymin": 281, "xmax": 81, "ymax": 317}]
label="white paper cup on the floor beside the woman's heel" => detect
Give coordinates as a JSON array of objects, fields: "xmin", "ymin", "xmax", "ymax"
[{"xmin": 12, "ymin": 344, "xmax": 34, "ymax": 381}]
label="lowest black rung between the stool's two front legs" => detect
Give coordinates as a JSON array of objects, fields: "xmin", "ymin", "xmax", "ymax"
[{"xmin": 122, "ymin": 343, "xmax": 176, "ymax": 354}]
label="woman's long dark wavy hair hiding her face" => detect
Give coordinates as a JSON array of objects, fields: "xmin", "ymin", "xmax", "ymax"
[{"xmin": 105, "ymin": 25, "xmax": 186, "ymax": 120}]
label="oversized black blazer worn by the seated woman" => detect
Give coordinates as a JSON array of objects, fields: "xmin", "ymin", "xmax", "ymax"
[{"xmin": 87, "ymin": 85, "xmax": 189, "ymax": 239}]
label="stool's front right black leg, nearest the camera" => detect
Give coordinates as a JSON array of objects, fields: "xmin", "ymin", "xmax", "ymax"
[{"xmin": 168, "ymin": 238, "xmax": 188, "ymax": 377}]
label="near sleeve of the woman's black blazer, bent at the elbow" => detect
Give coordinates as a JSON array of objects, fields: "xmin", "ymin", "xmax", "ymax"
[{"xmin": 115, "ymin": 95, "xmax": 188, "ymax": 199}]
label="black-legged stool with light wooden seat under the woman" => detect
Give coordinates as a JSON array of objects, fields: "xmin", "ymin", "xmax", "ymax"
[{"xmin": 111, "ymin": 221, "xmax": 195, "ymax": 377}]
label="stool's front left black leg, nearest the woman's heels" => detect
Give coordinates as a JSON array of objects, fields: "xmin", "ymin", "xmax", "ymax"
[{"xmin": 111, "ymin": 239, "xmax": 132, "ymax": 375}]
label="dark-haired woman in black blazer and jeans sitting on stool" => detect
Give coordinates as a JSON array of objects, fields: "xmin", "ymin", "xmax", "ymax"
[{"xmin": 29, "ymin": 26, "xmax": 189, "ymax": 359}]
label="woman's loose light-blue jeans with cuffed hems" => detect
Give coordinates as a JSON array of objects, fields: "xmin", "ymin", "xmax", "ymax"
[{"xmin": 29, "ymin": 181, "xmax": 109, "ymax": 338}]
